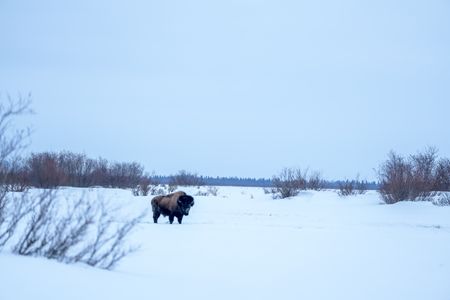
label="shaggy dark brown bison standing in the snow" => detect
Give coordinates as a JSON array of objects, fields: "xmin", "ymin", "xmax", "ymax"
[{"xmin": 152, "ymin": 191, "xmax": 194, "ymax": 224}]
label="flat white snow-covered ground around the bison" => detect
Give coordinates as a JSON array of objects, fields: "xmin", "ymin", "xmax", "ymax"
[{"xmin": 0, "ymin": 187, "xmax": 450, "ymax": 300}]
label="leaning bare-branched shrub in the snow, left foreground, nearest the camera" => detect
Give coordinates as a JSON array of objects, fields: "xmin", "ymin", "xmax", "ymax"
[{"xmin": 12, "ymin": 190, "xmax": 145, "ymax": 269}]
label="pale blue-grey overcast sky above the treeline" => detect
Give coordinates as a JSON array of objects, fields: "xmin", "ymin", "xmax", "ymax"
[{"xmin": 0, "ymin": 0, "xmax": 450, "ymax": 179}]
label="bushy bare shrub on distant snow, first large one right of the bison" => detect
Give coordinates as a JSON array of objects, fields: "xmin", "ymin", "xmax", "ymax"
[{"xmin": 272, "ymin": 168, "xmax": 308, "ymax": 199}]
